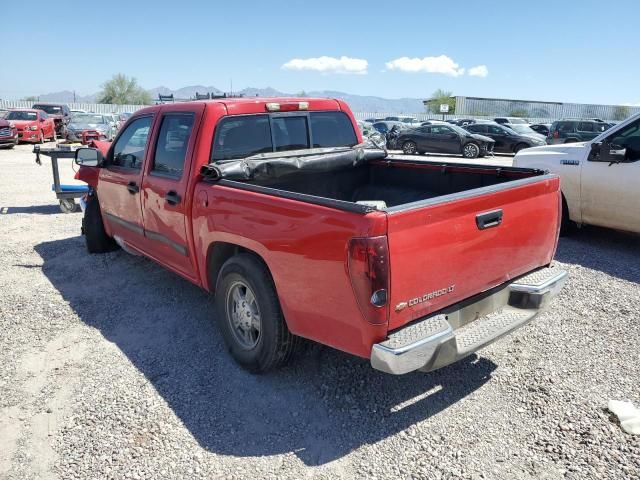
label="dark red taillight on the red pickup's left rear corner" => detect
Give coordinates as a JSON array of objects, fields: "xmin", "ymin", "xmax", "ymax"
[{"xmin": 349, "ymin": 236, "xmax": 389, "ymax": 324}]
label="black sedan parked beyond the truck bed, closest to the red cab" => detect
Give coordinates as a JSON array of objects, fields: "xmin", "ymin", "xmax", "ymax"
[{"xmin": 396, "ymin": 124, "xmax": 494, "ymax": 158}]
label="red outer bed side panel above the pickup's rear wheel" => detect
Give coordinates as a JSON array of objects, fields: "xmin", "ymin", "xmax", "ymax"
[{"xmin": 193, "ymin": 183, "xmax": 387, "ymax": 357}]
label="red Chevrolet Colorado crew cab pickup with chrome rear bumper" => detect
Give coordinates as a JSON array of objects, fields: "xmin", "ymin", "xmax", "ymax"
[{"xmin": 76, "ymin": 98, "xmax": 566, "ymax": 374}]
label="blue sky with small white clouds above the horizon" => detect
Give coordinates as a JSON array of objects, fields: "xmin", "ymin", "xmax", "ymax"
[{"xmin": 0, "ymin": 0, "xmax": 640, "ymax": 104}]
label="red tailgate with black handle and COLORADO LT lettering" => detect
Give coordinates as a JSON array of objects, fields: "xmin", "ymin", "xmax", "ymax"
[{"xmin": 388, "ymin": 175, "xmax": 561, "ymax": 330}]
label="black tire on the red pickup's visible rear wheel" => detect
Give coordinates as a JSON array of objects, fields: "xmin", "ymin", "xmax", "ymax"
[{"xmin": 215, "ymin": 253, "xmax": 298, "ymax": 373}]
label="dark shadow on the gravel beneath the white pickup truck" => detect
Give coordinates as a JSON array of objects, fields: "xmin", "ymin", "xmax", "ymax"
[{"xmin": 556, "ymin": 226, "xmax": 640, "ymax": 283}]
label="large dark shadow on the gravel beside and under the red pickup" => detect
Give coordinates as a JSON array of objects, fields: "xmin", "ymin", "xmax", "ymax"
[{"xmin": 36, "ymin": 237, "xmax": 496, "ymax": 465}]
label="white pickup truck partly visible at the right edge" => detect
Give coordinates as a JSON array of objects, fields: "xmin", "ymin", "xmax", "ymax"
[{"xmin": 513, "ymin": 114, "xmax": 640, "ymax": 234}]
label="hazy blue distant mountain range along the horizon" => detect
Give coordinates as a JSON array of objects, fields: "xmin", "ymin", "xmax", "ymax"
[{"xmin": 32, "ymin": 85, "xmax": 424, "ymax": 113}]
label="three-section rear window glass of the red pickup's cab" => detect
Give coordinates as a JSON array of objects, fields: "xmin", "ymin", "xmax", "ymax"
[{"xmin": 211, "ymin": 112, "xmax": 358, "ymax": 162}]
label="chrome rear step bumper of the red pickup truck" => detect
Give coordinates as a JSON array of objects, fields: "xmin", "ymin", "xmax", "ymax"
[{"xmin": 371, "ymin": 267, "xmax": 567, "ymax": 375}]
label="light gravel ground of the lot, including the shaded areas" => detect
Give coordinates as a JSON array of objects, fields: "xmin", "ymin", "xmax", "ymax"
[{"xmin": 0, "ymin": 146, "xmax": 640, "ymax": 480}]
